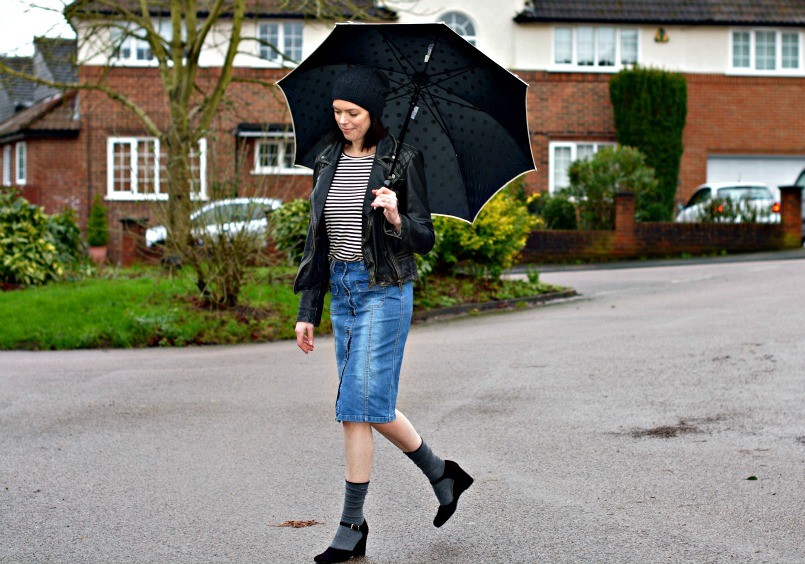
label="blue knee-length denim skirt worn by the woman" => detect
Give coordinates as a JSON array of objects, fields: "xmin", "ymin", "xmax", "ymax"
[{"xmin": 330, "ymin": 261, "xmax": 414, "ymax": 423}]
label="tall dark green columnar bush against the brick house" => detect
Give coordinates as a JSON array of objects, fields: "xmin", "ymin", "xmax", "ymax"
[{"xmin": 609, "ymin": 68, "xmax": 688, "ymax": 221}]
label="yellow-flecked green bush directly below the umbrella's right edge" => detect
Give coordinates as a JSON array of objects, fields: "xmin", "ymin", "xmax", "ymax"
[{"xmin": 418, "ymin": 186, "xmax": 542, "ymax": 277}]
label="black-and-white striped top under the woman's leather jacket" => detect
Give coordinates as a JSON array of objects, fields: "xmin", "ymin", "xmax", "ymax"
[{"xmin": 324, "ymin": 153, "xmax": 375, "ymax": 262}]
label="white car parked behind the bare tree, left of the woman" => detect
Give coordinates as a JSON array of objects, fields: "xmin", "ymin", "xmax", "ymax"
[{"xmin": 145, "ymin": 198, "xmax": 282, "ymax": 247}]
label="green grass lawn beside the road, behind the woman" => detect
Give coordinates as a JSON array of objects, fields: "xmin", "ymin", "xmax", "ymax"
[{"xmin": 0, "ymin": 268, "xmax": 557, "ymax": 350}]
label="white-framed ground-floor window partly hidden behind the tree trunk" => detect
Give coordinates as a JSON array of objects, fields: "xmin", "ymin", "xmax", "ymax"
[{"xmin": 106, "ymin": 137, "xmax": 207, "ymax": 200}]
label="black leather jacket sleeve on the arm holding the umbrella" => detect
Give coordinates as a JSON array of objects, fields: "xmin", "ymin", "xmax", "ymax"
[{"xmin": 385, "ymin": 150, "xmax": 436, "ymax": 255}]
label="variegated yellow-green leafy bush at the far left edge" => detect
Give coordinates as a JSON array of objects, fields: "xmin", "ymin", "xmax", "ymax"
[{"xmin": 0, "ymin": 190, "xmax": 76, "ymax": 286}]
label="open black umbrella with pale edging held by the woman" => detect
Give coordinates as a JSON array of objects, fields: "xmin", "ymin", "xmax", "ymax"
[{"xmin": 278, "ymin": 23, "xmax": 535, "ymax": 221}]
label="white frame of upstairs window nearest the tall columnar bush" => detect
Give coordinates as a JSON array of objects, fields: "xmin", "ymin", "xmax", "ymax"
[{"xmin": 549, "ymin": 25, "xmax": 641, "ymax": 73}]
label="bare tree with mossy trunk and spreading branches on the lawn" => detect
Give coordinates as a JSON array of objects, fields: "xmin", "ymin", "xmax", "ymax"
[{"xmin": 0, "ymin": 0, "xmax": 375, "ymax": 305}]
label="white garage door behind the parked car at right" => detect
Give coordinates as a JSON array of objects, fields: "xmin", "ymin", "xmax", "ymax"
[{"xmin": 707, "ymin": 155, "xmax": 805, "ymax": 186}]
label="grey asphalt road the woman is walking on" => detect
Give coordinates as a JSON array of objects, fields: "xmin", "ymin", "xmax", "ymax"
[{"xmin": 0, "ymin": 260, "xmax": 805, "ymax": 564}]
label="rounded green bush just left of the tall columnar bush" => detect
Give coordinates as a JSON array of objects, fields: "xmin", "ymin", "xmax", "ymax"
[{"xmin": 563, "ymin": 147, "xmax": 657, "ymax": 229}]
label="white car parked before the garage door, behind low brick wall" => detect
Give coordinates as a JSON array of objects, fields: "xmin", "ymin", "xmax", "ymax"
[{"xmin": 676, "ymin": 182, "xmax": 780, "ymax": 223}]
